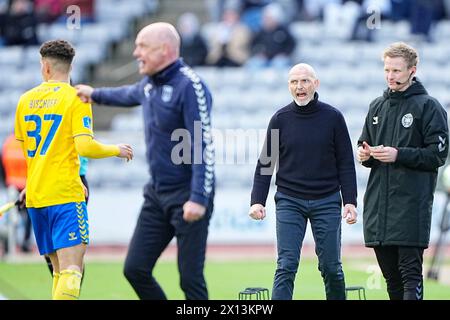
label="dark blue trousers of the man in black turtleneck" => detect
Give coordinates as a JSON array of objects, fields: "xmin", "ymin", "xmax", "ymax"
[{"xmin": 272, "ymin": 192, "xmax": 345, "ymax": 300}]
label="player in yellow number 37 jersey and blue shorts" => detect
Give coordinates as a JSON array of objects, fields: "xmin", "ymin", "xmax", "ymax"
[{"xmin": 15, "ymin": 40, "xmax": 133, "ymax": 300}]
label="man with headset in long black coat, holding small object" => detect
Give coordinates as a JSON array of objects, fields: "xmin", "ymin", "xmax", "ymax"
[{"xmin": 357, "ymin": 42, "xmax": 448, "ymax": 300}]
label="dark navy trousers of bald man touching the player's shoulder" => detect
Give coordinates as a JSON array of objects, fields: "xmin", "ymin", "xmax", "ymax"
[{"xmin": 124, "ymin": 184, "xmax": 213, "ymax": 300}]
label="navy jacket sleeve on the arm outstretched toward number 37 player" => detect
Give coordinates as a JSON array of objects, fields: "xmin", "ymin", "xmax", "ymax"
[{"xmin": 92, "ymin": 81, "xmax": 144, "ymax": 107}]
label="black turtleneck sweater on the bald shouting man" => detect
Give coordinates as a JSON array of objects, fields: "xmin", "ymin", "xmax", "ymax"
[{"xmin": 251, "ymin": 93, "xmax": 357, "ymax": 206}]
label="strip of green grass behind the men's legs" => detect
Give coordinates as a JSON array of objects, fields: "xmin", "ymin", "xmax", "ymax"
[{"xmin": 0, "ymin": 258, "xmax": 450, "ymax": 300}]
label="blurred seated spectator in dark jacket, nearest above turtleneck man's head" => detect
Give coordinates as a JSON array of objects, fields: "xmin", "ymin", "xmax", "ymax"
[{"xmin": 247, "ymin": 3, "xmax": 296, "ymax": 68}]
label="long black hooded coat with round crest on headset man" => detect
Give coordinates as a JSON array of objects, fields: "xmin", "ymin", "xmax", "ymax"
[{"xmin": 358, "ymin": 78, "xmax": 448, "ymax": 248}]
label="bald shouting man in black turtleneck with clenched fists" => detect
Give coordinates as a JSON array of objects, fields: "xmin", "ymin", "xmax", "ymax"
[{"xmin": 249, "ymin": 63, "xmax": 357, "ymax": 300}]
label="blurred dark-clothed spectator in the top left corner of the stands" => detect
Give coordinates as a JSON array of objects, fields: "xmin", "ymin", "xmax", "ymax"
[{"xmin": 0, "ymin": 0, "xmax": 38, "ymax": 46}]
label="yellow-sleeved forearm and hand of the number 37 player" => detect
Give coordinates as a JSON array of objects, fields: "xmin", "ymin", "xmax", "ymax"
[{"xmin": 74, "ymin": 135, "xmax": 133, "ymax": 160}]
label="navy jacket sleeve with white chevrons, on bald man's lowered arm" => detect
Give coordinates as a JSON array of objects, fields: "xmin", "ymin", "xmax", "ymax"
[{"xmin": 182, "ymin": 78, "xmax": 214, "ymax": 206}]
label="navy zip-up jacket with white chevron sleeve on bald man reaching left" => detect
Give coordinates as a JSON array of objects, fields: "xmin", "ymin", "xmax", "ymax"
[{"xmin": 92, "ymin": 59, "xmax": 214, "ymax": 206}]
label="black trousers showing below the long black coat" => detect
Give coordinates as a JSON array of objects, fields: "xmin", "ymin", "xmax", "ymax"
[{"xmin": 374, "ymin": 246, "xmax": 424, "ymax": 300}]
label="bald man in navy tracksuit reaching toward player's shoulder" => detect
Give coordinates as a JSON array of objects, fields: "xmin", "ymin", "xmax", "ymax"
[{"xmin": 77, "ymin": 22, "xmax": 214, "ymax": 300}]
